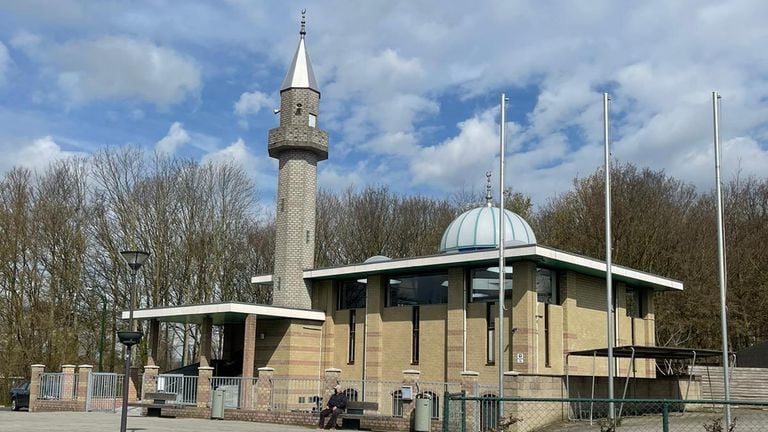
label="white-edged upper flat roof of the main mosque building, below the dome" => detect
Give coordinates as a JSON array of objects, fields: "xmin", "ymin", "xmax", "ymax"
[{"xmin": 251, "ymin": 245, "xmax": 683, "ymax": 291}]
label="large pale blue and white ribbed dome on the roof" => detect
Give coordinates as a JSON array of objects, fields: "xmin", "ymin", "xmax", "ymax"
[{"xmin": 440, "ymin": 205, "xmax": 536, "ymax": 252}]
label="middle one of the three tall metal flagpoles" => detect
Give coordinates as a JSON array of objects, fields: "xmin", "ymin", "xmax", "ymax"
[{"xmin": 603, "ymin": 93, "xmax": 614, "ymax": 420}]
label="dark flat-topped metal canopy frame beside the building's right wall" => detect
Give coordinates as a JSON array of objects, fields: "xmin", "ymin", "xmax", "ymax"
[{"xmin": 565, "ymin": 345, "xmax": 735, "ymax": 424}]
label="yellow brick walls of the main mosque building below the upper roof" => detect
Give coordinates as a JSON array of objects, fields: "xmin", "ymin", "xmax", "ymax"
[{"xmin": 308, "ymin": 261, "xmax": 655, "ymax": 384}]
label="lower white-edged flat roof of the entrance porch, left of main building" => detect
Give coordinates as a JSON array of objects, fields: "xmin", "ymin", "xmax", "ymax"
[{"xmin": 121, "ymin": 303, "xmax": 325, "ymax": 325}]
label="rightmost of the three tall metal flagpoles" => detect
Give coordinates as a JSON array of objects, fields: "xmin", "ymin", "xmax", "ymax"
[{"xmin": 712, "ymin": 92, "xmax": 731, "ymax": 430}]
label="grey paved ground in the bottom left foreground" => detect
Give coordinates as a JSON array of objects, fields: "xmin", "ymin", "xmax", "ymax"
[{"xmin": 0, "ymin": 409, "xmax": 320, "ymax": 432}]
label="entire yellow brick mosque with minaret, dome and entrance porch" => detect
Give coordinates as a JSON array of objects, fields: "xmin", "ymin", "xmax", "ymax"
[{"xmin": 124, "ymin": 12, "xmax": 683, "ymax": 426}]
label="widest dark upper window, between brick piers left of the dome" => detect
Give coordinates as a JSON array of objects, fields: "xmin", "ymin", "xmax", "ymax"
[{"xmin": 387, "ymin": 273, "xmax": 448, "ymax": 306}]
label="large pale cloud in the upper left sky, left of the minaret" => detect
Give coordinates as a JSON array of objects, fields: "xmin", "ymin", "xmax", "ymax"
[{"xmin": 47, "ymin": 36, "xmax": 201, "ymax": 107}]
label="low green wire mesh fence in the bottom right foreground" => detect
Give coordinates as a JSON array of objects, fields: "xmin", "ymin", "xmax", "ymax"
[{"xmin": 443, "ymin": 393, "xmax": 768, "ymax": 432}]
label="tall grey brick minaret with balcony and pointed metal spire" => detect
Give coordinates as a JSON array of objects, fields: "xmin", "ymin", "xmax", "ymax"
[{"xmin": 269, "ymin": 11, "xmax": 328, "ymax": 309}]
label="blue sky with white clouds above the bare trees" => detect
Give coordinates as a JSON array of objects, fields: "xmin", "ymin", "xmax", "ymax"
[{"xmin": 0, "ymin": 0, "xmax": 768, "ymax": 207}]
